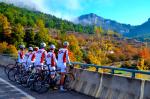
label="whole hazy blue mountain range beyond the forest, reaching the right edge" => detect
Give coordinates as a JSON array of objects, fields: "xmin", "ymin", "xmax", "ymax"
[{"xmin": 76, "ymin": 13, "xmax": 150, "ymax": 37}]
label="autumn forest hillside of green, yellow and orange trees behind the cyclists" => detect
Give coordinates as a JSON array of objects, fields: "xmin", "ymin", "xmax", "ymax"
[{"xmin": 0, "ymin": 3, "xmax": 150, "ymax": 70}]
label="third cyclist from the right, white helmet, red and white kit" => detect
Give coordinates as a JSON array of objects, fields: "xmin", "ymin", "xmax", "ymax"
[{"xmin": 34, "ymin": 42, "xmax": 47, "ymax": 69}]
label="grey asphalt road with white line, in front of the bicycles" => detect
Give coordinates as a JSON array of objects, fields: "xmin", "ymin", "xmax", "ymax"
[{"xmin": 0, "ymin": 66, "xmax": 93, "ymax": 99}]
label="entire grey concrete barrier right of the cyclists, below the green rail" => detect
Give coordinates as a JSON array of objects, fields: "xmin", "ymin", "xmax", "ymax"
[{"xmin": 70, "ymin": 69, "xmax": 150, "ymax": 99}]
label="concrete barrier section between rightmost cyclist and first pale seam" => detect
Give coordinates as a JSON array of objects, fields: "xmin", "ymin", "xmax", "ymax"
[{"xmin": 70, "ymin": 69, "xmax": 101, "ymax": 97}]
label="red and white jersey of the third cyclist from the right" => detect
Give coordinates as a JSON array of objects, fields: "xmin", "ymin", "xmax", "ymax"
[{"xmin": 35, "ymin": 49, "xmax": 47, "ymax": 65}]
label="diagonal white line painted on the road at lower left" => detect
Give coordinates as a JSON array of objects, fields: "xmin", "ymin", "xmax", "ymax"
[{"xmin": 0, "ymin": 78, "xmax": 35, "ymax": 99}]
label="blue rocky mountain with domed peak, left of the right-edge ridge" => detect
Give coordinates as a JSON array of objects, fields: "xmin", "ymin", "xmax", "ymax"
[{"xmin": 76, "ymin": 13, "xmax": 132, "ymax": 34}]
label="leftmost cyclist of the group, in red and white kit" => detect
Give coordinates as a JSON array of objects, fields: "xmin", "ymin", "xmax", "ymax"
[{"xmin": 18, "ymin": 45, "xmax": 25, "ymax": 63}]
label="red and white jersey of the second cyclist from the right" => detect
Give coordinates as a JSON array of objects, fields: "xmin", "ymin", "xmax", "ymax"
[{"xmin": 46, "ymin": 52, "xmax": 57, "ymax": 67}]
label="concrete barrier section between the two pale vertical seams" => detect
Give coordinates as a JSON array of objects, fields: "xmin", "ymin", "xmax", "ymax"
[{"xmin": 97, "ymin": 74, "xmax": 141, "ymax": 99}]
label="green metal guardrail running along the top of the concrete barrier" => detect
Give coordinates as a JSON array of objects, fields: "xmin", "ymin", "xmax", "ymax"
[{"xmin": 72, "ymin": 62, "xmax": 150, "ymax": 78}]
